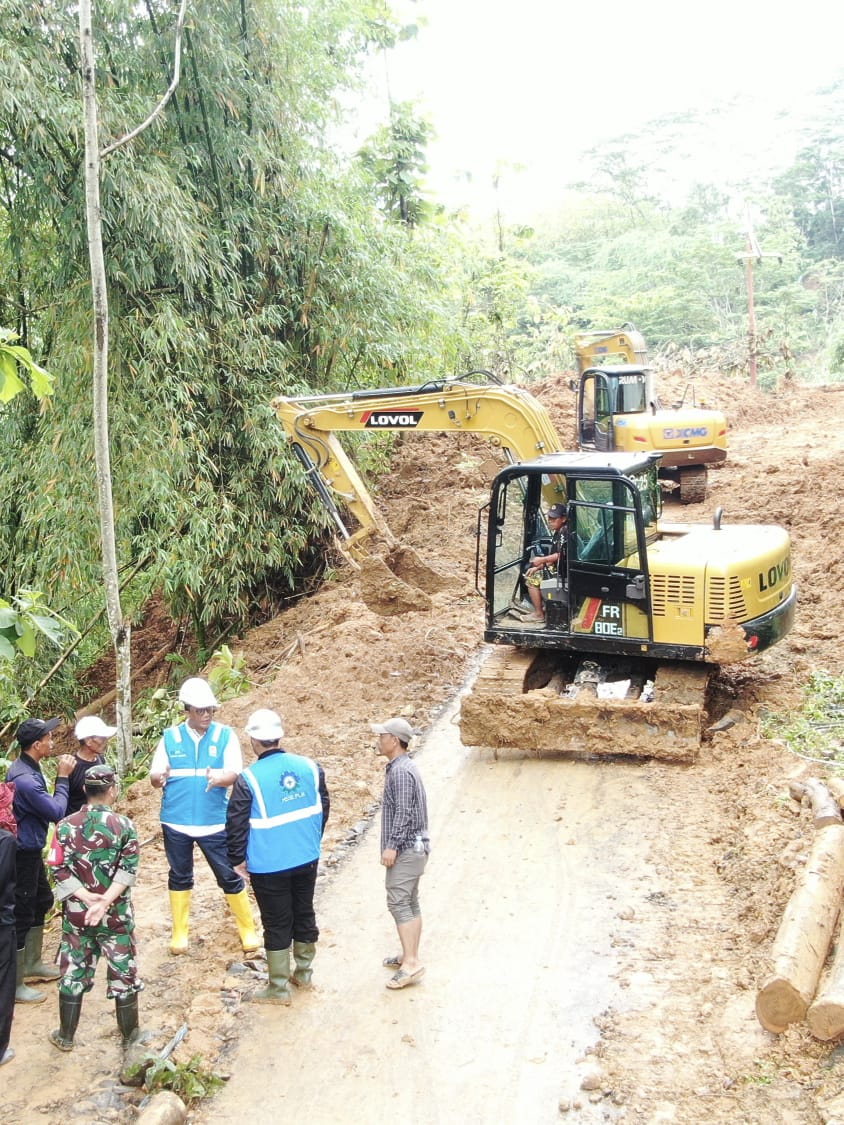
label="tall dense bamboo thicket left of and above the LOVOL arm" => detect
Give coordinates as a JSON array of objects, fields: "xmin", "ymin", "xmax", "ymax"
[{"xmin": 0, "ymin": 0, "xmax": 470, "ymax": 647}]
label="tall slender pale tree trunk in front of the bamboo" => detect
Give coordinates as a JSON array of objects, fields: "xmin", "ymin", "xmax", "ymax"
[{"xmin": 79, "ymin": 0, "xmax": 133, "ymax": 776}]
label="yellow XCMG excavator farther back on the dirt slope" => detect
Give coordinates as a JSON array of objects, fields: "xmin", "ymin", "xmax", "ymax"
[{"xmin": 575, "ymin": 324, "xmax": 727, "ymax": 504}]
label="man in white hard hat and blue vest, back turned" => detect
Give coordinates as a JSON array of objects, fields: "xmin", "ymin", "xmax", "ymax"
[{"xmin": 226, "ymin": 708, "xmax": 331, "ymax": 1004}]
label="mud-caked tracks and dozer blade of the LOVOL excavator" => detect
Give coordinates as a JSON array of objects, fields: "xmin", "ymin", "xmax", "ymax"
[{"xmin": 460, "ymin": 647, "xmax": 712, "ymax": 762}]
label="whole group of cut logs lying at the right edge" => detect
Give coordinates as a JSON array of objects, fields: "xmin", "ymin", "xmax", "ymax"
[{"xmin": 756, "ymin": 779, "xmax": 844, "ymax": 1040}]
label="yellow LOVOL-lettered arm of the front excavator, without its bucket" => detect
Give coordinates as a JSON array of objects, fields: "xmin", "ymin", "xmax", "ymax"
[{"xmin": 272, "ymin": 379, "xmax": 562, "ymax": 556}]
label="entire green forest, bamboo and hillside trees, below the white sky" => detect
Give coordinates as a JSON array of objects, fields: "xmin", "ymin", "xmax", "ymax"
[{"xmin": 0, "ymin": 0, "xmax": 844, "ymax": 721}]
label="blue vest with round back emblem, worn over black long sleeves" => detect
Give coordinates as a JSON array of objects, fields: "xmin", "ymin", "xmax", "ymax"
[{"xmin": 241, "ymin": 753, "xmax": 322, "ymax": 874}]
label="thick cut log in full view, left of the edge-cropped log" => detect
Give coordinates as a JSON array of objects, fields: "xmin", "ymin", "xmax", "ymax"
[{"xmin": 756, "ymin": 825, "xmax": 844, "ymax": 1034}]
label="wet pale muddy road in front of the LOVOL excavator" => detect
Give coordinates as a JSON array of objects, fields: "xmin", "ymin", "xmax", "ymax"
[{"xmin": 199, "ymin": 697, "xmax": 666, "ymax": 1125}]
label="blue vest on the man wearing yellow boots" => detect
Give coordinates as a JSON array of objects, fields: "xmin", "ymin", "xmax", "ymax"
[{"xmin": 161, "ymin": 722, "xmax": 232, "ymax": 828}]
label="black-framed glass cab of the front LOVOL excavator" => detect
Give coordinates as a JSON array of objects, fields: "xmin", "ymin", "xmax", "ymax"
[{"xmin": 485, "ymin": 453, "xmax": 662, "ymax": 654}]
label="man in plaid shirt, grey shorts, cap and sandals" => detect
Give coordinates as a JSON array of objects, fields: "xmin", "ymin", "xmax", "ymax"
[{"xmin": 372, "ymin": 719, "xmax": 430, "ymax": 989}]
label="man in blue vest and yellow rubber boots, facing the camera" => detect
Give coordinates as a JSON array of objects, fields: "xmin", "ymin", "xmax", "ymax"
[{"xmin": 150, "ymin": 676, "xmax": 261, "ymax": 954}]
